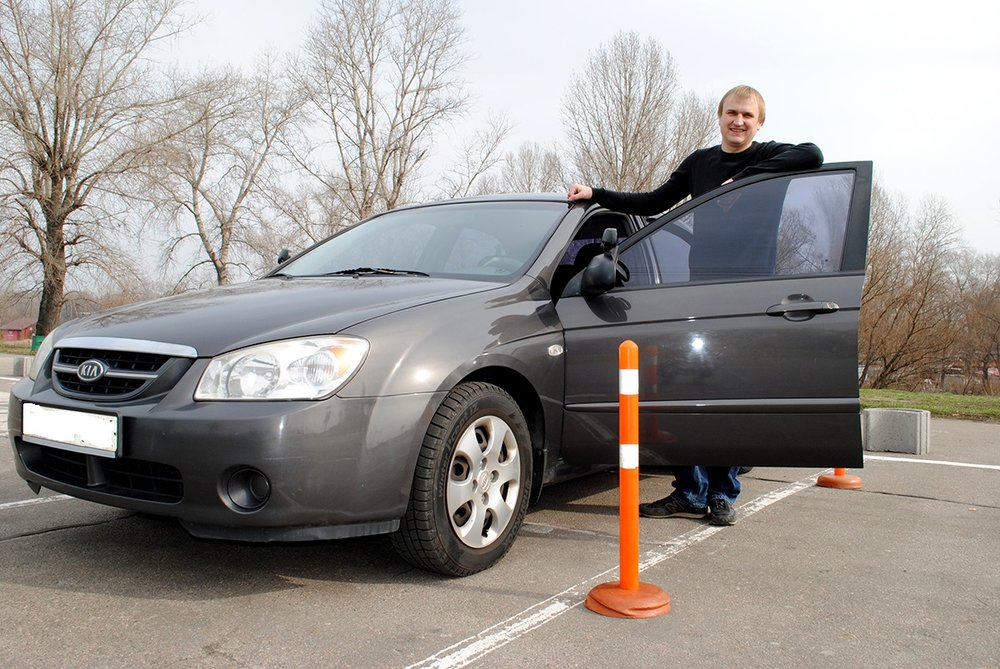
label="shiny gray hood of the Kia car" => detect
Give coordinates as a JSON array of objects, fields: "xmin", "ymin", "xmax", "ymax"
[{"xmin": 56, "ymin": 276, "xmax": 497, "ymax": 357}]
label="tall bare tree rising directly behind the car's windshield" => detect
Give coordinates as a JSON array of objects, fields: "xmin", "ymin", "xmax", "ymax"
[{"xmin": 295, "ymin": 0, "xmax": 467, "ymax": 220}]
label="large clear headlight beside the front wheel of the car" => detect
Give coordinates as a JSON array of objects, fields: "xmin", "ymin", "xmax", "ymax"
[{"xmin": 194, "ymin": 337, "xmax": 368, "ymax": 400}]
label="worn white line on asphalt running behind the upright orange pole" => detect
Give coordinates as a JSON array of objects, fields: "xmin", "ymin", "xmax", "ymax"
[{"xmin": 407, "ymin": 474, "xmax": 816, "ymax": 669}]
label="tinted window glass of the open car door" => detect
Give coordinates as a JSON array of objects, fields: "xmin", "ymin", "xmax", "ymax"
[{"xmin": 621, "ymin": 173, "xmax": 853, "ymax": 287}]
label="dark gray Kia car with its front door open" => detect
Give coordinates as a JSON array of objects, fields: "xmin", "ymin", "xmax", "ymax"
[{"xmin": 8, "ymin": 163, "xmax": 872, "ymax": 575}]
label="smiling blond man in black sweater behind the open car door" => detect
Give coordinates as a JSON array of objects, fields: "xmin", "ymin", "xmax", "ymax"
[{"xmin": 569, "ymin": 86, "xmax": 823, "ymax": 525}]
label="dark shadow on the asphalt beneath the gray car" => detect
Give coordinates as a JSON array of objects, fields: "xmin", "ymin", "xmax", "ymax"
[{"xmin": 0, "ymin": 470, "xmax": 680, "ymax": 601}]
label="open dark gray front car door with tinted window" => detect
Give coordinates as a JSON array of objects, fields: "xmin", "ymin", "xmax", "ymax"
[{"xmin": 556, "ymin": 162, "xmax": 872, "ymax": 467}]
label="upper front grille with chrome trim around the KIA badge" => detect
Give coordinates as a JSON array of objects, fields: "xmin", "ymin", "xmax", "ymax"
[{"xmin": 52, "ymin": 348, "xmax": 171, "ymax": 400}]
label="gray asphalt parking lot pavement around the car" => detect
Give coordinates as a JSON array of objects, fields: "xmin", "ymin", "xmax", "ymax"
[{"xmin": 0, "ymin": 352, "xmax": 1000, "ymax": 668}]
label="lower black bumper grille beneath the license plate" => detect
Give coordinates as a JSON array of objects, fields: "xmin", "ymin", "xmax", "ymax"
[{"xmin": 37, "ymin": 446, "xmax": 184, "ymax": 504}]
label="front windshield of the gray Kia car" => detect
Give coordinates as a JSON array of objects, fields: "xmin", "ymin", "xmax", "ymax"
[{"xmin": 280, "ymin": 202, "xmax": 566, "ymax": 280}]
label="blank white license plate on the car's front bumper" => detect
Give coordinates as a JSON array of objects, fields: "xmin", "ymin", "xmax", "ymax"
[{"xmin": 21, "ymin": 403, "xmax": 119, "ymax": 458}]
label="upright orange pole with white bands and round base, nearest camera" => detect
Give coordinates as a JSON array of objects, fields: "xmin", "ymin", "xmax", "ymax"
[{"xmin": 584, "ymin": 340, "xmax": 670, "ymax": 618}]
